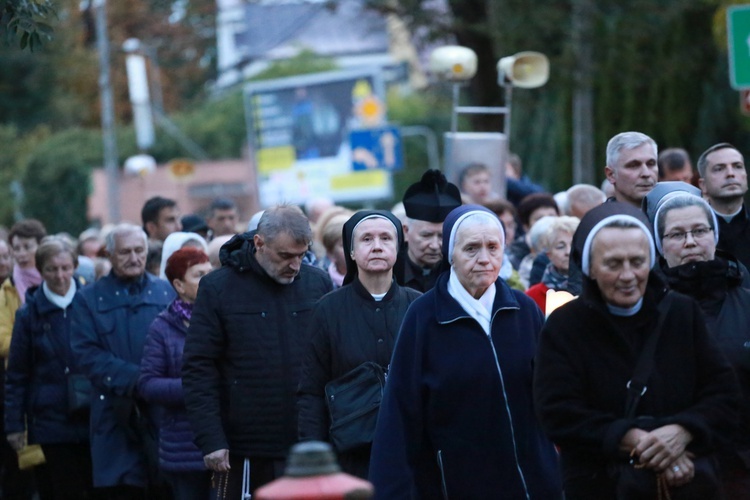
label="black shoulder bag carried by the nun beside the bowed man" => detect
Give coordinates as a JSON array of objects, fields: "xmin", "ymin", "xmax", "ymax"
[{"xmin": 325, "ymin": 361, "xmax": 386, "ymax": 451}]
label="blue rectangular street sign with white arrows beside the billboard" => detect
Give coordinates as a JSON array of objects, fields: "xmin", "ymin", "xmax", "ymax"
[{"xmin": 349, "ymin": 126, "xmax": 404, "ymax": 171}]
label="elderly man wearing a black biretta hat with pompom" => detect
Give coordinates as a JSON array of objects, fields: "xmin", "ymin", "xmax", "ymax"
[{"xmin": 393, "ymin": 170, "xmax": 461, "ymax": 293}]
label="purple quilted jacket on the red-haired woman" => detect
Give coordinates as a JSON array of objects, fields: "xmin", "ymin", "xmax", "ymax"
[{"xmin": 138, "ymin": 302, "xmax": 206, "ymax": 472}]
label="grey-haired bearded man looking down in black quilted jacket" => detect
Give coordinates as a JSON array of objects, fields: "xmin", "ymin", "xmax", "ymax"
[{"xmin": 182, "ymin": 205, "xmax": 333, "ymax": 498}]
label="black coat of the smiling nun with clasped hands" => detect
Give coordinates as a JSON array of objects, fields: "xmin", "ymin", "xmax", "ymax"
[{"xmin": 534, "ymin": 273, "xmax": 738, "ymax": 498}]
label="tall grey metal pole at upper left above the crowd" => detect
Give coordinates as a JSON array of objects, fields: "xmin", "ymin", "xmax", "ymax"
[{"xmin": 94, "ymin": 0, "xmax": 120, "ymax": 224}]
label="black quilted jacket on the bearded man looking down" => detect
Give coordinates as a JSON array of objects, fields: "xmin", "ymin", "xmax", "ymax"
[{"xmin": 182, "ymin": 233, "xmax": 333, "ymax": 458}]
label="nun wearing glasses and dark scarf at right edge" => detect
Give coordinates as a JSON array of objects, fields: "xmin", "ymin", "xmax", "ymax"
[{"xmin": 644, "ymin": 182, "xmax": 750, "ymax": 498}]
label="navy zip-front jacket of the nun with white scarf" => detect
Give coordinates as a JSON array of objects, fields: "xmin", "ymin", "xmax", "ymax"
[{"xmin": 370, "ymin": 273, "xmax": 561, "ymax": 500}]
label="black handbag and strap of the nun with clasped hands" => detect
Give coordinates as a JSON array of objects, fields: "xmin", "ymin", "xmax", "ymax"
[{"xmin": 608, "ymin": 291, "xmax": 721, "ymax": 500}]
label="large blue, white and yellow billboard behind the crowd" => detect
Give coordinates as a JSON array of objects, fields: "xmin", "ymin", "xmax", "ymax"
[{"xmin": 244, "ymin": 69, "xmax": 393, "ymax": 207}]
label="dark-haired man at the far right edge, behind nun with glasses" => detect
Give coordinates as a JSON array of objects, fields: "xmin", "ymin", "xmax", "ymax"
[{"xmin": 698, "ymin": 142, "xmax": 750, "ymax": 267}]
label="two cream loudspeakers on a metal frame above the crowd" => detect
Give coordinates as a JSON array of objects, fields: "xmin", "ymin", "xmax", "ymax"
[{"xmin": 430, "ymin": 45, "xmax": 549, "ymax": 196}]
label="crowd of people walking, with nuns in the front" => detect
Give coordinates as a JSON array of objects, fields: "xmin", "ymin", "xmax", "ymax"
[{"xmin": 0, "ymin": 132, "xmax": 750, "ymax": 500}]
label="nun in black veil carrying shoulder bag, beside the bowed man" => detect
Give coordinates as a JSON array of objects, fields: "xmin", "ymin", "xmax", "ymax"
[{"xmin": 299, "ymin": 210, "xmax": 421, "ymax": 479}]
